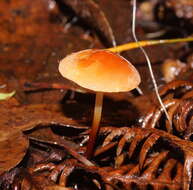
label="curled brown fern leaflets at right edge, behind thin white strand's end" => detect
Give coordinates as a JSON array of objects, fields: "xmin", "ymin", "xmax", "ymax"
[{"xmin": 142, "ymin": 81, "xmax": 193, "ymax": 140}]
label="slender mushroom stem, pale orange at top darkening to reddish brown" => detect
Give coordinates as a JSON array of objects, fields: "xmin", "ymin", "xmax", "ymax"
[{"xmin": 86, "ymin": 92, "xmax": 103, "ymax": 159}]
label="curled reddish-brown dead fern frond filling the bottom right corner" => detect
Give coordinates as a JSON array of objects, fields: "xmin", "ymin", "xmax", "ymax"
[{"xmin": 96, "ymin": 127, "xmax": 193, "ymax": 190}]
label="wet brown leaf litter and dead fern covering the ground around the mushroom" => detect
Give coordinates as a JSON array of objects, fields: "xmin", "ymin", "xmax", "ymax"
[{"xmin": 0, "ymin": 0, "xmax": 193, "ymax": 190}]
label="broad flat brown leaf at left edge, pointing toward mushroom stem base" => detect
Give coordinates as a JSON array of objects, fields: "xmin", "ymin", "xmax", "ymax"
[{"xmin": 0, "ymin": 98, "xmax": 87, "ymax": 174}]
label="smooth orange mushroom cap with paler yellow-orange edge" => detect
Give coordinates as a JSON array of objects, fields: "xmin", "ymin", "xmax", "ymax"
[{"xmin": 59, "ymin": 49, "xmax": 141, "ymax": 92}]
